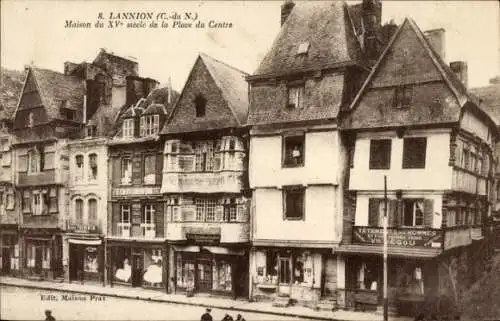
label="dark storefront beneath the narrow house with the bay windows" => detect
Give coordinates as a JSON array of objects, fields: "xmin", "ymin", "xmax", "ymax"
[{"xmin": 170, "ymin": 245, "xmax": 248, "ymax": 297}]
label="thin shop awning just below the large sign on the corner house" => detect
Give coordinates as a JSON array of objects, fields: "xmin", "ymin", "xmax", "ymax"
[{"xmin": 334, "ymin": 244, "xmax": 441, "ymax": 258}]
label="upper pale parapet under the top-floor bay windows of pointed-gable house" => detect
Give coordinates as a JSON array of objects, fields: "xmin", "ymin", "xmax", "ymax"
[{"xmin": 162, "ymin": 171, "xmax": 243, "ymax": 193}]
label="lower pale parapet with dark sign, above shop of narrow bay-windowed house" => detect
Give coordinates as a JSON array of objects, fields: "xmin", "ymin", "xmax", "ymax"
[{"xmin": 167, "ymin": 222, "xmax": 250, "ymax": 244}]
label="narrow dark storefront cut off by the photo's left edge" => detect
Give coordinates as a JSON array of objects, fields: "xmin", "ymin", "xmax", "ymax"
[{"xmin": 0, "ymin": 228, "xmax": 19, "ymax": 276}]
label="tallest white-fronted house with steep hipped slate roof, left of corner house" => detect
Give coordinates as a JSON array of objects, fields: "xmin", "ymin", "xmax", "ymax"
[{"xmin": 247, "ymin": 1, "xmax": 391, "ymax": 308}]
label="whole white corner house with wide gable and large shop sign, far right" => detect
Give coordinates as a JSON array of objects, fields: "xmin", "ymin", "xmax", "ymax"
[{"xmin": 337, "ymin": 19, "xmax": 498, "ymax": 315}]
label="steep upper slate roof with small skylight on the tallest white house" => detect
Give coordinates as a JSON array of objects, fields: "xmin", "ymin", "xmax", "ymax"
[{"xmin": 254, "ymin": 1, "xmax": 362, "ymax": 75}]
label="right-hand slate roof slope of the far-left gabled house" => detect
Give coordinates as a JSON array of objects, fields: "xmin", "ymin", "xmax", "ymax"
[{"xmin": 30, "ymin": 67, "xmax": 85, "ymax": 120}]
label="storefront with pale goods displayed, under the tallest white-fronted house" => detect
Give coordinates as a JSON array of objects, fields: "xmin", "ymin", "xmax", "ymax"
[{"xmin": 251, "ymin": 248, "xmax": 328, "ymax": 303}]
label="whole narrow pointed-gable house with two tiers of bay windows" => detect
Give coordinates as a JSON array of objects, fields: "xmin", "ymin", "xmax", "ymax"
[{"xmin": 161, "ymin": 54, "xmax": 250, "ymax": 297}]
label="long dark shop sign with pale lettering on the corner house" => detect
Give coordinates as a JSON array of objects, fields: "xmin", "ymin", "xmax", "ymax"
[{"xmin": 352, "ymin": 226, "xmax": 442, "ymax": 248}]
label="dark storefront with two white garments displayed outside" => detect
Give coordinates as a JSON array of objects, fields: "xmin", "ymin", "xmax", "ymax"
[{"xmin": 106, "ymin": 239, "xmax": 167, "ymax": 291}]
